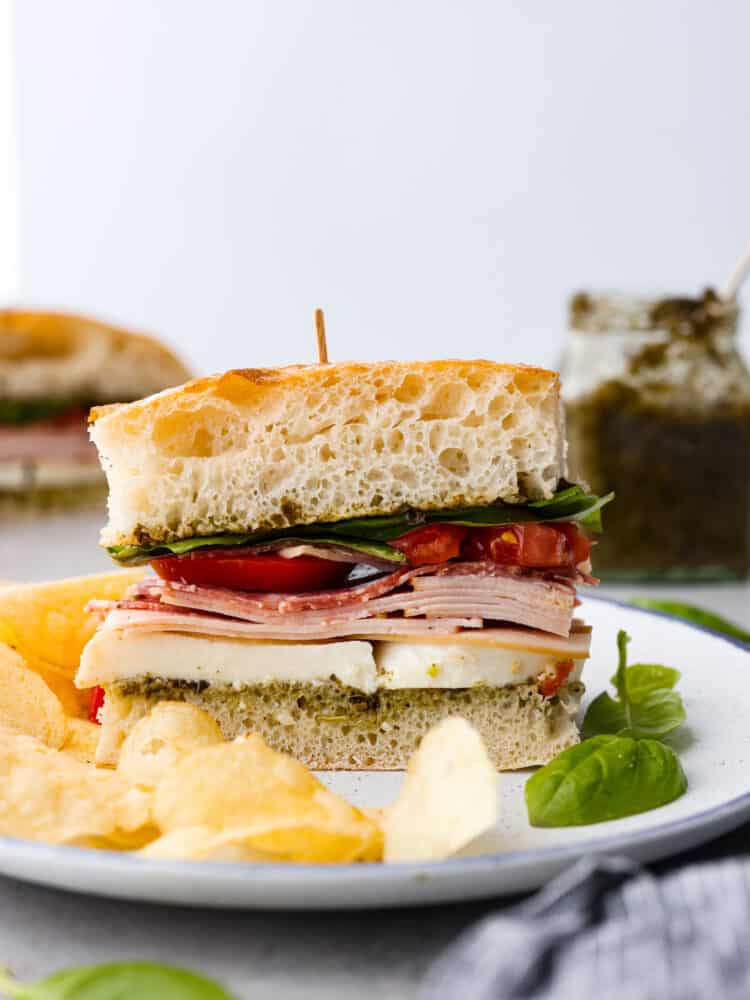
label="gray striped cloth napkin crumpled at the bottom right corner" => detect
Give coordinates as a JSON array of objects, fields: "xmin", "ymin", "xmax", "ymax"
[{"xmin": 420, "ymin": 858, "xmax": 750, "ymax": 1000}]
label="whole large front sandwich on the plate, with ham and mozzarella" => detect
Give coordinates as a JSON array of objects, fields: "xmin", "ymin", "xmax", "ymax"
[{"xmin": 76, "ymin": 361, "xmax": 607, "ymax": 770}]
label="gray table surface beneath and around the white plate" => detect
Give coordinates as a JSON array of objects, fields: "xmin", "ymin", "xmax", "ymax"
[{"xmin": 0, "ymin": 518, "xmax": 750, "ymax": 1000}]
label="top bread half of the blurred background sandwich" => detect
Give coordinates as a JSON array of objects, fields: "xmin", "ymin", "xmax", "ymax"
[{"xmin": 0, "ymin": 309, "xmax": 190, "ymax": 403}]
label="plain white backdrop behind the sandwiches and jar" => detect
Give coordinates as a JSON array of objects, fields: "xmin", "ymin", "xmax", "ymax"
[{"xmin": 6, "ymin": 0, "xmax": 750, "ymax": 370}]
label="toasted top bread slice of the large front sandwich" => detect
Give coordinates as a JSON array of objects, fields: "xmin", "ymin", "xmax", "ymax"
[{"xmin": 91, "ymin": 361, "xmax": 565, "ymax": 545}]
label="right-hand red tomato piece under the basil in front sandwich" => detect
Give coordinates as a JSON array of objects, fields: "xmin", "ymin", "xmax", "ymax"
[{"xmin": 463, "ymin": 523, "xmax": 591, "ymax": 569}]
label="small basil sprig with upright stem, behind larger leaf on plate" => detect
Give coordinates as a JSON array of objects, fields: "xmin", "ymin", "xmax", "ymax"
[{"xmin": 582, "ymin": 631, "xmax": 686, "ymax": 740}]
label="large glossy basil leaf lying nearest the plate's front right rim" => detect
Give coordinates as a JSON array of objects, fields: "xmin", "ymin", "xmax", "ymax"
[{"xmin": 525, "ymin": 736, "xmax": 687, "ymax": 827}]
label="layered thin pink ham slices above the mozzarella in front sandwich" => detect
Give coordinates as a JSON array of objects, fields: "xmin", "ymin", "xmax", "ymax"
[{"xmin": 117, "ymin": 563, "xmax": 575, "ymax": 639}]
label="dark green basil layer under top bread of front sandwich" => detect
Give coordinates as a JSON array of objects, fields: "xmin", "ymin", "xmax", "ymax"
[{"xmin": 108, "ymin": 484, "xmax": 614, "ymax": 565}]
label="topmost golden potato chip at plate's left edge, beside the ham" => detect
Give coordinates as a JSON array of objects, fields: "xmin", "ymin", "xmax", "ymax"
[{"xmin": 0, "ymin": 569, "xmax": 145, "ymax": 680}]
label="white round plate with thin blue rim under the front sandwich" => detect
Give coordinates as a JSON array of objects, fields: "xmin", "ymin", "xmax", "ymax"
[{"xmin": 0, "ymin": 598, "xmax": 750, "ymax": 909}]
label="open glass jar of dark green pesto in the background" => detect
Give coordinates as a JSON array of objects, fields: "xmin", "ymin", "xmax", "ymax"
[{"xmin": 561, "ymin": 290, "xmax": 750, "ymax": 581}]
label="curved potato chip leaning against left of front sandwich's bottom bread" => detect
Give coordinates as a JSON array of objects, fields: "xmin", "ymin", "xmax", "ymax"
[{"xmin": 117, "ymin": 701, "xmax": 224, "ymax": 788}]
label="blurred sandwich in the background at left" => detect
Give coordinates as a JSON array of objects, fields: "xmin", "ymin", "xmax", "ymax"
[{"xmin": 0, "ymin": 310, "xmax": 189, "ymax": 511}]
